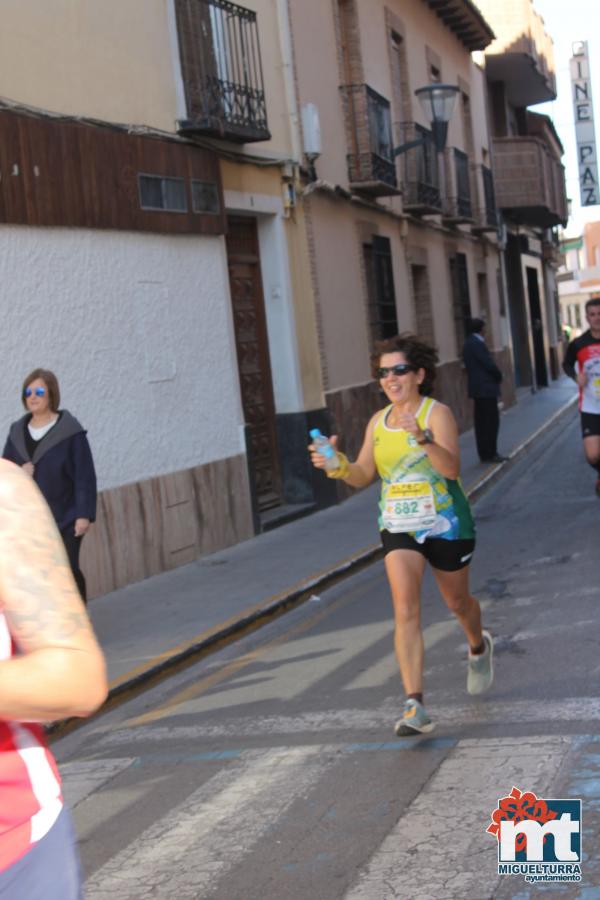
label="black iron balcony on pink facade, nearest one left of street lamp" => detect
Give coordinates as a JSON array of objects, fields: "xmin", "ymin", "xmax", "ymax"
[{"xmin": 340, "ymin": 84, "xmax": 399, "ymax": 197}]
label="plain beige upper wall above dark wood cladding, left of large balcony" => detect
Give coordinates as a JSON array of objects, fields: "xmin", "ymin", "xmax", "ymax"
[{"xmin": 0, "ymin": 0, "xmax": 177, "ymax": 131}]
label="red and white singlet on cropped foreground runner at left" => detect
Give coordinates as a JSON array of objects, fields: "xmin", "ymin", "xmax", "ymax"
[{"xmin": 0, "ymin": 611, "xmax": 63, "ymax": 872}]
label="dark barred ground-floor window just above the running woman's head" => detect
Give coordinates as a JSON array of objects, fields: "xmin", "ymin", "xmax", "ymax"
[{"xmin": 363, "ymin": 235, "xmax": 398, "ymax": 341}]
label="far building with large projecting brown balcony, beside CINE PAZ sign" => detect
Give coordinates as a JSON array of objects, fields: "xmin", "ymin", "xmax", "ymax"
[{"xmin": 479, "ymin": 0, "xmax": 568, "ymax": 389}]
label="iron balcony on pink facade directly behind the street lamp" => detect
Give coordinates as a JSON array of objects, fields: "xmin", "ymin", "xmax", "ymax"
[{"xmin": 396, "ymin": 122, "xmax": 442, "ymax": 215}]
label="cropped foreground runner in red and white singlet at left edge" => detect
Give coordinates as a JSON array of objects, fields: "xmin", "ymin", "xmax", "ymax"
[{"xmin": 0, "ymin": 460, "xmax": 107, "ymax": 900}]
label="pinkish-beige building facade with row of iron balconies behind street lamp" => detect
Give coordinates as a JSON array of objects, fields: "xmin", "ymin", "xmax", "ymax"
[{"xmin": 290, "ymin": 0, "xmax": 513, "ymax": 464}]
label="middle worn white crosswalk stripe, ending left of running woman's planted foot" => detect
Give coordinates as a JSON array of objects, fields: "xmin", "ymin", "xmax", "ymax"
[{"xmin": 85, "ymin": 746, "xmax": 336, "ymax": 900}]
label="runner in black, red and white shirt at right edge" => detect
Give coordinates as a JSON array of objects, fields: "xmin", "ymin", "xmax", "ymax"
[{"xmin": 563, "ymin": 297, "xmax": 600, "ymax": 497}]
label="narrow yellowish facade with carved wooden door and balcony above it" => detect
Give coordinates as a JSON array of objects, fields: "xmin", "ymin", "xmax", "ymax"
[{"xmin": 175, "ymin": 0, "xmax": 331, "ymax": 531}]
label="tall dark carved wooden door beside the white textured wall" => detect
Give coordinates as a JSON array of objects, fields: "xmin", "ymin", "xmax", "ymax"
[{"xmin": 227, "ymin": 216, "xmax": 281, "ymax": 511}]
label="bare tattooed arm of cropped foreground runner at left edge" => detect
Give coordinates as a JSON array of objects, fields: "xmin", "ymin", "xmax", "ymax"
[{"xmin": 0, "ymin": 460, "xmax": 107, "ymax": 722}]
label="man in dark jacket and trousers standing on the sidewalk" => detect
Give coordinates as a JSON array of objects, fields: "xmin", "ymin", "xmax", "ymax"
[{"xmin": 463, "ymin": 319, "xmax": 507, "ymax": 463}]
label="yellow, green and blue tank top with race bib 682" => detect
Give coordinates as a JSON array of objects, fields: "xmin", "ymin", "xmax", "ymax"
[{"xmin": 373, "ymin": 397, "xmax": 475, "ymax": 543}]
